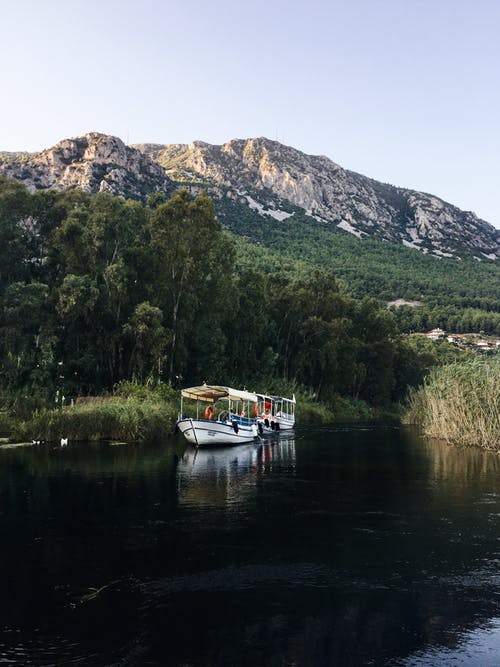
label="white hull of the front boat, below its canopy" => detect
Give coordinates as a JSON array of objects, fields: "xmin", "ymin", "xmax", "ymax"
[{"xmin": 177, "ymin": 419, "xmax": 258, "ymax": 447}]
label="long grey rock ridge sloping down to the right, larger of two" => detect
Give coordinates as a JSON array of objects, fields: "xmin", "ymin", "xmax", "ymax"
[{"xmin": 138, "ymin": 138, "xmax": 500, "ymax": 260}]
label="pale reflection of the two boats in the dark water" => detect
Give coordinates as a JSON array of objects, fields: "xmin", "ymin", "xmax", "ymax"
[{"xmin": 177, "ymin": 433, "xmax": 295, "ymax": 507}]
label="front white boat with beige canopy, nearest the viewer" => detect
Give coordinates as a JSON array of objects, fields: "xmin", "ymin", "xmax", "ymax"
[{"xmin": 176, "ymin": 384, "xmax": 258, "ymax": 447}]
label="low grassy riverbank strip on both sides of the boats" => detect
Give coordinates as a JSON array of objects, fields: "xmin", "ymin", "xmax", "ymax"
[{"xmin": 0, "ymin": 383, "xmax": 399, "ymax": 442}]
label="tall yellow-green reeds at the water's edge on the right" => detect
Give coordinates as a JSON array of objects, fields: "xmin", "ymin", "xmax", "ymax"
[{"xmin": 407, "ymin": 356, "xmax": 500, "ymax": 450}]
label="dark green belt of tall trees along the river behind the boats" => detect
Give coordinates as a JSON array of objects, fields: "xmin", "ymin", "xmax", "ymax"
[{"xmin": 0, "ymin": 177, "xmax": 440, "ymax": 404}]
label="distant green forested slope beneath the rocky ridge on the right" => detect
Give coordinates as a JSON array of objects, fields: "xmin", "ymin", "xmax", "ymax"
[{"xmin": 221, "ymin": 200, "xmax": 500, "ymax": 335}]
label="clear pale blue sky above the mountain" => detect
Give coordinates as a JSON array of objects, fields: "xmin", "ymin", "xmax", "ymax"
[{"xmin": 0, "ymin": 0, "xmax": 500, "ymax": 228}]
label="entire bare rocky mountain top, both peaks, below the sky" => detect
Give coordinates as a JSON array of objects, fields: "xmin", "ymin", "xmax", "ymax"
[{"xmin": 0, "ymin": 132, "xmax": 500, "ymax": 260}]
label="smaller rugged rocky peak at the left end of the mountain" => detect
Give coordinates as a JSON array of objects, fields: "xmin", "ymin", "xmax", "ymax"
[{"xmin": 0, "ymin": 132, "xmax": 172, "ymax": 199}]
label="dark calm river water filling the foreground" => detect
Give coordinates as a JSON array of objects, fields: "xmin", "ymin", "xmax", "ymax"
[{"xmin": 0, "ymin": 426, "xmax": 500, "ymax": 667}]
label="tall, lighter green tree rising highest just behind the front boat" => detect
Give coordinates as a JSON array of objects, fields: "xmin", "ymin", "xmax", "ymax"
[{"xmin": 149, "ymin": 190, "xmax": 233, "ymax": 380}]
